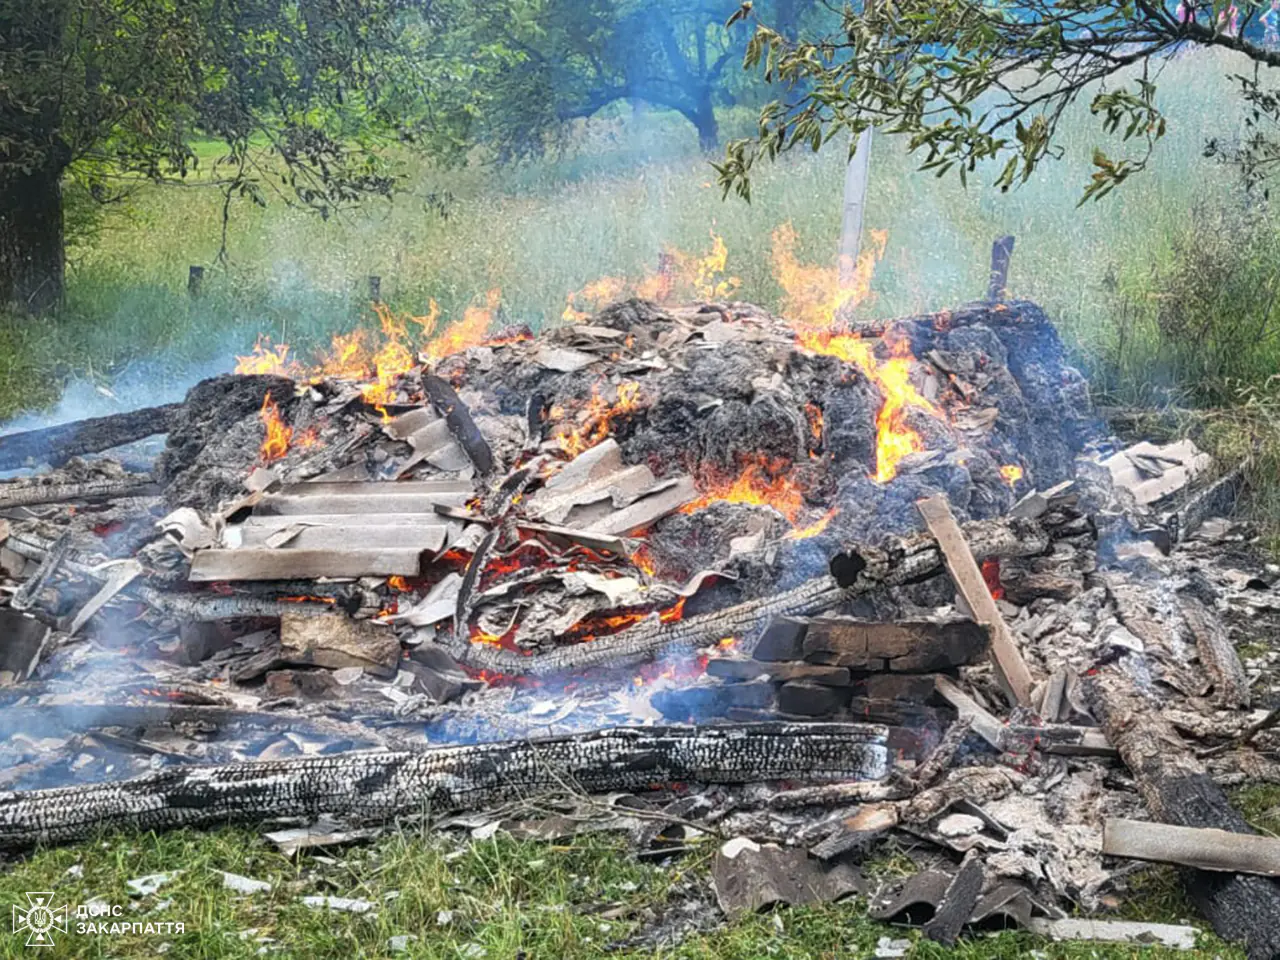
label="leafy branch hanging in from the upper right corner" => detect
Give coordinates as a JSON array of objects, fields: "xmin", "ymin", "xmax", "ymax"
[{"xmin": 717, "ymin": 0, "xmax": 1280, "ymax": 202}]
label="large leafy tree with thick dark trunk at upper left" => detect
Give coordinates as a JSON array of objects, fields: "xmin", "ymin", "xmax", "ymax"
[{"xmin": 0, "ymin": 0, "xmax": 435, "ymax": 310}]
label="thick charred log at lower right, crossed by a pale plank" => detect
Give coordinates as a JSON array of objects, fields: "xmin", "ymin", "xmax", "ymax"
[{"xmin": 1082, "ymin": 652, "xmax": 1280, "ymax": 957}]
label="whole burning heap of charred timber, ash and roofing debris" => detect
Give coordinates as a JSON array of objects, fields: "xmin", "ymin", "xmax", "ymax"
[{"xmin": 0, "ymin": 301, "xmax": 1280, "ymax": 956}]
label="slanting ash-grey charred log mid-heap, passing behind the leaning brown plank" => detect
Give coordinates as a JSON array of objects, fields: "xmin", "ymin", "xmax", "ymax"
[{"xmin": 453, "ymin": 520, "xmax": 1050, "ymax": 676}]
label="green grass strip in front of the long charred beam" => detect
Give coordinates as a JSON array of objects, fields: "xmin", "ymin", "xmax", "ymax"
[{"xmin": 0, "ymin": 829, "xmax": 1243, "ymax": 960}]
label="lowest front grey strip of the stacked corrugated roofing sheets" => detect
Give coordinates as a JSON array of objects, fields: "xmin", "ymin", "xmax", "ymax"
[{"xmin": 187, "ymin": 547, "xmax": 422, "ymax": 584}]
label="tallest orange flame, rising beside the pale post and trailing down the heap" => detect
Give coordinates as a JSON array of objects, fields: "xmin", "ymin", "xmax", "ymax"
[{"xmin": 773, "ymin": 224, "xmax": 938, "ymax": 484}]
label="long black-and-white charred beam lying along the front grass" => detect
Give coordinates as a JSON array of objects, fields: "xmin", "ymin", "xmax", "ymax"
[{"xmin": 0, "ymin": 723, "xmax": 890, "ymax": 850}]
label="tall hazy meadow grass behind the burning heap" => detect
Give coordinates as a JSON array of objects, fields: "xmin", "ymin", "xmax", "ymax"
[{"xmin": 0, "ymin": 52, "xmax": 1280, "ymax": 413}]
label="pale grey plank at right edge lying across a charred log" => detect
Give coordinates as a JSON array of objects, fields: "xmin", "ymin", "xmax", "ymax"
[{"xmin": 1102, "ymin": 819, "xmax": 1280, "ymax": 877}]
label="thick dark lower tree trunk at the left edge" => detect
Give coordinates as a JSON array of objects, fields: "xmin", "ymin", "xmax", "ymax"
[{"xmin": 0, "ymin": 163, "xmax": 65, "ymax": 312}]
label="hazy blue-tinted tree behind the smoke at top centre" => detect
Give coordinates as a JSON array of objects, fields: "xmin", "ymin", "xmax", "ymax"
[{"xmin": 435, "ymin": 0, "xmax": 819, "ymax": 156}]
